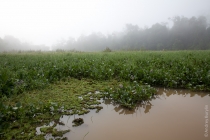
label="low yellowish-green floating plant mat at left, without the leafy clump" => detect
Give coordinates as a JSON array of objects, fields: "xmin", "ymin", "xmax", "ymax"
[{"xmin": 0, "ymin": 78, "xmax": 120, "ymax": 140}]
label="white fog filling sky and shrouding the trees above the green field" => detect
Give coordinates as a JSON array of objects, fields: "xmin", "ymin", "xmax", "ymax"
[{"xmin": 0, "ymin": 0, "xmax": 210, "ymax": 51}]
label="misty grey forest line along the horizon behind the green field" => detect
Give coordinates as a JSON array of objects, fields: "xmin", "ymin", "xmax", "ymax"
[{"xmin": 0, "ymin": 16, "xmax": 210, "ymax": 51}]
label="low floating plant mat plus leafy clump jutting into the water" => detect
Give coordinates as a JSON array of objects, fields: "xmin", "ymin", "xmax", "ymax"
[{"xmin": 0, "ymin": 78, "xmax": 155, "ymax": 140}]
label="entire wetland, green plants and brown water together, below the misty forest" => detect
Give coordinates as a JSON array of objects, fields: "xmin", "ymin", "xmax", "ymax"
[{"xmin": 0, "ymin": 51, "xmax": 210, "ymax": 140}]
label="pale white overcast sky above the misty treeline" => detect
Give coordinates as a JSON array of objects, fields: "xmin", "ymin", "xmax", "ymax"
[{"xmin": 0, "ymin": 0, "xmax": 210, "ymax": 45}]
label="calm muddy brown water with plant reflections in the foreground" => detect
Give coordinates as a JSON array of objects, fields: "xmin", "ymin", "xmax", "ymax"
[{"xmin": 57, "ymin": 89, "xmax": 210, "ymax": 140}]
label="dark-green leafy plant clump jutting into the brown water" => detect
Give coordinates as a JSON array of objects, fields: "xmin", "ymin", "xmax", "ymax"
[{"xmin": 104, "ymin": 81, "xmax": 155, "ymax": 109}]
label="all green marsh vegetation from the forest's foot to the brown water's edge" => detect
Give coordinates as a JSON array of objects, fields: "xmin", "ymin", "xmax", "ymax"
[{"xmin": 0, "ymin": 51, "xmax": 210, "ymax": 139}]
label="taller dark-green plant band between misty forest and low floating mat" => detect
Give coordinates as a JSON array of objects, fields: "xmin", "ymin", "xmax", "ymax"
[{"xmin": 0, "ymin": 51, "xmax": 210, "ymax": 97}]
